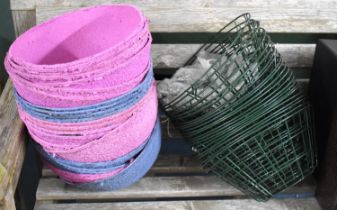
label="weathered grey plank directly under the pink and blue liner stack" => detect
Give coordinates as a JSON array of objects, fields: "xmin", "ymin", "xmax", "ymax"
[{"xmin": 36, "ymin": 176, "xmax": 315, "ymax": 201}]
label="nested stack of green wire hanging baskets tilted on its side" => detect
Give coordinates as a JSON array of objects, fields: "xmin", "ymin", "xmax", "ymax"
[{"xmin": 161, "ymin": 14, "xmax": 317, "ymax": 201}]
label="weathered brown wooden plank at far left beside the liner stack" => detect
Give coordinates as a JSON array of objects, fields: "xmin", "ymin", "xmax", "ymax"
[{"xmin": 0, "ymin": 81, "xmax": 26, "ymax": 204}]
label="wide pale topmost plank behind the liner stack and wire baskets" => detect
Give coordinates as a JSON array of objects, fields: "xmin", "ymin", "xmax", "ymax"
[{"xmin": 36, "ymin": 5, "xmax": 337, "ymax": 33}]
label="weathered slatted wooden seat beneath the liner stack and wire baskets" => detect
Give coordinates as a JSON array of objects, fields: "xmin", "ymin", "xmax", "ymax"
[{"xmin": 35, "ymin": 154, "xmax": 320, "ymax": 210}]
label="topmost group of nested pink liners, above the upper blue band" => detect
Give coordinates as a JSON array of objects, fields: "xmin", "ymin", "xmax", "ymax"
[{"xmin": 5, "ymin": 5, "xmax": 152, "ymax": 108}]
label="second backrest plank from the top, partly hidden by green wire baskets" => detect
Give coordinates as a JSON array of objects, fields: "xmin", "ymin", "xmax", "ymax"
[{"xmin": 152, "ymin": 44, "xmax": 316, "ymax": 68}]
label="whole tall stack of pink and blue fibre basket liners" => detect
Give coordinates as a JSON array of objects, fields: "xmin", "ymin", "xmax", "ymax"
[{"xmin": 5, "ymin": 5, "xmax": 160, "ymax": 190}]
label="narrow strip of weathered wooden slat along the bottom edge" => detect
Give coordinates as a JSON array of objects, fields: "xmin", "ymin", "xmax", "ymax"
[{"xmin": 35, "ymin": 198, "xmax": 321, "ymax": 210}]
